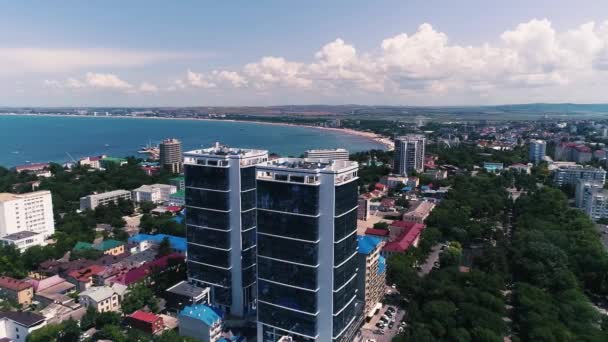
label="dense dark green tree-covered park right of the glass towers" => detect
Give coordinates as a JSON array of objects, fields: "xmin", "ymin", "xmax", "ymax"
[{"xmin": 387, "ymin": 173, "xmax": 608, "ymax": 342}]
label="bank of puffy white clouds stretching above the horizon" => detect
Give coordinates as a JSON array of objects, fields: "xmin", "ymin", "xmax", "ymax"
[{"xmin": 30, "ymin": 19, "xmax": 608, "ymax": 104}]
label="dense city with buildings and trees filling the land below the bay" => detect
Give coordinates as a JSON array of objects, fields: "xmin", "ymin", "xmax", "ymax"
[{"xmin": 0, "ymin": 118, "xmax": 608, "ymax": 342}]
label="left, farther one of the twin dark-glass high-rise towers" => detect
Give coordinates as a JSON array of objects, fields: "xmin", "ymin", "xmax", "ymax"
[{"xmin": 184, "ymin": 144, "xmax": 268, "ymax": 317}]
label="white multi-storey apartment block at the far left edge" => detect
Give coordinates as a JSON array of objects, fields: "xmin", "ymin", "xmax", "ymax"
[{"xmin": 0, "ymin": 191, "xmax": 55, "ymax": 239}]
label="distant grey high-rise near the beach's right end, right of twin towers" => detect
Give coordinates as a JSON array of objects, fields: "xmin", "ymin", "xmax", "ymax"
[{"xmin": 393, "ymin": 134, "xmax": 426, "ymax": 175}]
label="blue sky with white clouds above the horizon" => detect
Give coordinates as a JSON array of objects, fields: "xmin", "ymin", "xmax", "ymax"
[{"xmin": 0, "ymin": 0, "xmax": 608, "ymax": 107}]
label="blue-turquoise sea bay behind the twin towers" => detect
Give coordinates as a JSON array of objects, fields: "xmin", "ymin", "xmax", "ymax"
[{"xmin": 0, "ymin": 115, "xmax": 384, "ymax": 167}]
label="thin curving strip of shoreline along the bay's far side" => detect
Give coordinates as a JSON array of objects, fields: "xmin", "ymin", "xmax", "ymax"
[{"xmin": 0, "ymin": 113, "xmax": 394, "ymax": 151}]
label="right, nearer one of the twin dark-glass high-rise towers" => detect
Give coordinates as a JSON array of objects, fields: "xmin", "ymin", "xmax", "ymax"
[{"xmin": 256, "ymin": 158, "xmax": 363, "ymax": 342}]
